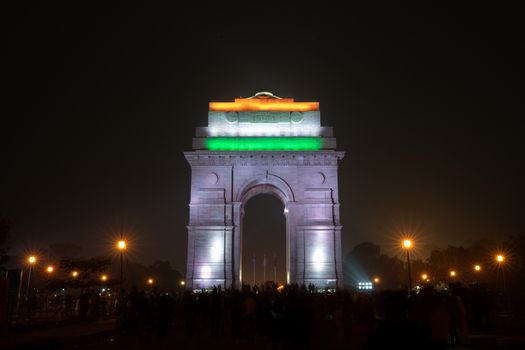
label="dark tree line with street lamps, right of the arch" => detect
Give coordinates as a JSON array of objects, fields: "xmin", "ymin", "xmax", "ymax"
[{"xmin": 344, "ymin": 234, "xmax": 525, "ymax": 295}]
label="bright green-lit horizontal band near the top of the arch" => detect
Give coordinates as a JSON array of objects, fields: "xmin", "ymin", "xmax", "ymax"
[{"xmin": 206, "ymin": 137, "xmax": 322, "ymax": 151}]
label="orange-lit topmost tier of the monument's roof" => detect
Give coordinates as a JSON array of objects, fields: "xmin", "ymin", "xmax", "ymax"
[{"xmin": 210, "ymin": 92, "xmax": 319, "ymax": 112}]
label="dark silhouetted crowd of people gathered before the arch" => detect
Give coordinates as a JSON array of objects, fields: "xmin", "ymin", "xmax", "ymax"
[{"xmin": 99, "ymin": 284, "xmax": 504, "ymax": 349}]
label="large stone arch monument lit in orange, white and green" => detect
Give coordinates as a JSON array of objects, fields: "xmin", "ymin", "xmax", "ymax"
[{"xmin": 184, "ymin": 93, "xmax": 344, "ymax": 289}]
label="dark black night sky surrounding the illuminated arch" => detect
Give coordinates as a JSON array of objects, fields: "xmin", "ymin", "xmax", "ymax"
[{"xmin": 0, "ymin": 2, "xmax": 525, "ymax": 271}]
